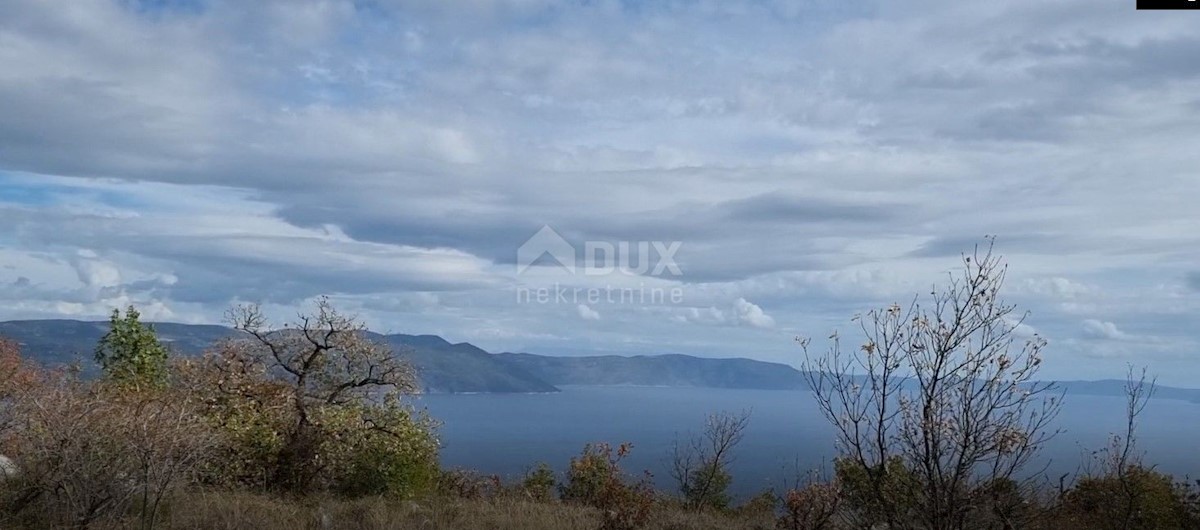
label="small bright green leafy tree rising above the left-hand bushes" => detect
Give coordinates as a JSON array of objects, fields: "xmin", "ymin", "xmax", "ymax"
[{"xmin": 96, "ymin": 306, "xmax": 167, "ymax": 387}]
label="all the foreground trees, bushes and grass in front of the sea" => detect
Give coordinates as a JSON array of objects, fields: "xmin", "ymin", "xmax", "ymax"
[{"xmin": 0, "ymin": 242, "xmax": 1200, "ymax": 530}]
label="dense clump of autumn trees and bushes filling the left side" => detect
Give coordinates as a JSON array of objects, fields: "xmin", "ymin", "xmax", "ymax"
[{"xmin": 0, "ymin": 301, "xmax": 438, "ymax": 529}]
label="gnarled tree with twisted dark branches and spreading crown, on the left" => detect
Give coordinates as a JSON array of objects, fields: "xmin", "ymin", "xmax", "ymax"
[{"xmin": 227, "ymin": 297, "xmax": 418, "ymax": 492}]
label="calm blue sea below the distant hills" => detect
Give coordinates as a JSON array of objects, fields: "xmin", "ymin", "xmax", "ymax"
[{"xmin": 416, "ymin": 386, "xmax": 1200, "ymax": 495}]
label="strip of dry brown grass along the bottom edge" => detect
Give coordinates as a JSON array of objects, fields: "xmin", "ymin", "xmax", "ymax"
[{"xmin": 117, "ymin": 493, "xmax": 774, "ymax": 530}]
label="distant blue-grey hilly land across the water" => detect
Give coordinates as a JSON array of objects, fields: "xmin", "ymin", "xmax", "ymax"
[{"xmin": 0, "ymin": 320, "xmax": 1200, "ymax": 403}]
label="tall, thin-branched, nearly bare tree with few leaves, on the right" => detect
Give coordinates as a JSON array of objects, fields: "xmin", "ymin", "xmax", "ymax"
[{"xmin": 798, "ymin": 240, "xmax": 1061, "ymax": 530}]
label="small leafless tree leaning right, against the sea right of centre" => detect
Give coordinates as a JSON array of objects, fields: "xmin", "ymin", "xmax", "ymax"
[{"xmin": 671, "ymin": 410, "xmax": 750, "ymax": 510}]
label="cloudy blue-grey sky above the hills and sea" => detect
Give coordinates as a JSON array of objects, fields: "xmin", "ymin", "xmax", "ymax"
[{"xmin": 0, "ymin": 0, "xmax": 1200, "ymax": 387}]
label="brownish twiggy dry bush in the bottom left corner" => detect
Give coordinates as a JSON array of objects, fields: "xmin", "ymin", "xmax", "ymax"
[{"xmin": 6, "ymin": 375, "xmax": 212, "ymax": 529}]
